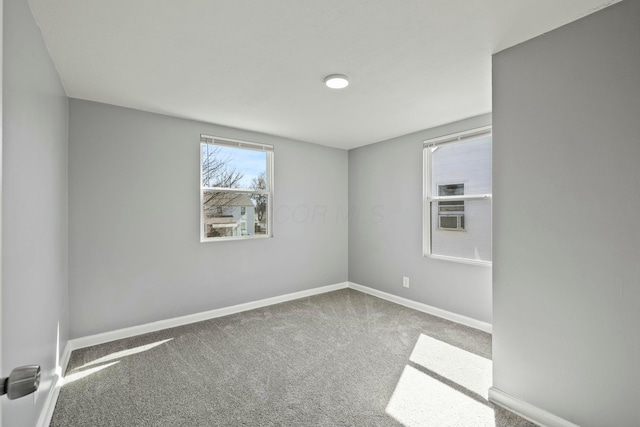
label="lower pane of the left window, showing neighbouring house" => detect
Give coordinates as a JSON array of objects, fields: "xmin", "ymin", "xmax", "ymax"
[{"xmin": 202, "ymin": 190, "xmax": 269, "ymax": 238}]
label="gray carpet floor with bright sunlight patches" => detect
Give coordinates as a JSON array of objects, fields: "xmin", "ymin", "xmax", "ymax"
[{"xmin": 50, "ymin": 289, "xmax": 534, "ymax": 427}]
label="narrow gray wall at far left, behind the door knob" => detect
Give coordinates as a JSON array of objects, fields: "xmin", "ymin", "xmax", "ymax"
[{"xmin": 1, "ymin": 0, "xmax": 69, "ymax": 427}]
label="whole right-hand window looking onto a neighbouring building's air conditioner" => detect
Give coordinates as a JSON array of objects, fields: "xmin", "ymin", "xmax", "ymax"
[{"xmin": 424, "ymin": 127, "xmax": 492, "ymax": 265}]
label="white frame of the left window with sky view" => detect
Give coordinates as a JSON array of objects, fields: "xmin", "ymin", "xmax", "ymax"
[{"xmin": 199, "ymin": 134, "xmax": 274, "ymax": 243}]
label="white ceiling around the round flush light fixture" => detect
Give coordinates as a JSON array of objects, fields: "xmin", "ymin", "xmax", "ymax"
[{"xmin": 29, "ymin": 0, "xmax": 617, "ymax": 149}]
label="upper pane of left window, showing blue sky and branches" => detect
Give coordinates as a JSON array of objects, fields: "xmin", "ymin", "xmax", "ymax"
[{"xmin": 201, "ymin": 144, "xmax": 268, "ymax": 190}]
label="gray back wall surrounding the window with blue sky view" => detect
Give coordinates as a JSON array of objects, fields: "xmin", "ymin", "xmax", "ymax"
[{"xmin": 69, "ymin": 99, "xmax": 348, "ymax": 338}]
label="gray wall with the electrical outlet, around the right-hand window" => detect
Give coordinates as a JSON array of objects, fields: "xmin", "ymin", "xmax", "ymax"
[{"xmin": 349, "ymin": 115, "xmax": 492, "ymax": 323}]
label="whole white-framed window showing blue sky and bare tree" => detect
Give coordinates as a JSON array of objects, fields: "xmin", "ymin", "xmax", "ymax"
[{"xmin": 200, "ymin": 135, "xmax": 273, "ymax": 242}]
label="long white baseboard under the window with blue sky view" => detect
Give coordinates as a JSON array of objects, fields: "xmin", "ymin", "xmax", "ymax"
[{"xmin": 69, "ymin": 282, "xmax": 348, "ymax": 351}]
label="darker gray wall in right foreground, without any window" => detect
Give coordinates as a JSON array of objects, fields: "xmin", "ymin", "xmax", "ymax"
[{"xmin": 493, "ymin": 0, "xmax": 640, "ymax": 426}]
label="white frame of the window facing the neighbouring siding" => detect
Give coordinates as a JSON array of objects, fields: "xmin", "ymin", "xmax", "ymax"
[{"xmin": 422, "ymin": 125, "xmax": 493, "ymax": 267}]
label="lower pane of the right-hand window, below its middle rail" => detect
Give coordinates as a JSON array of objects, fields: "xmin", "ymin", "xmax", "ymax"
[{"xmin": 431, "ymin": 200, "xmax": 491, "ymax": 261}]
